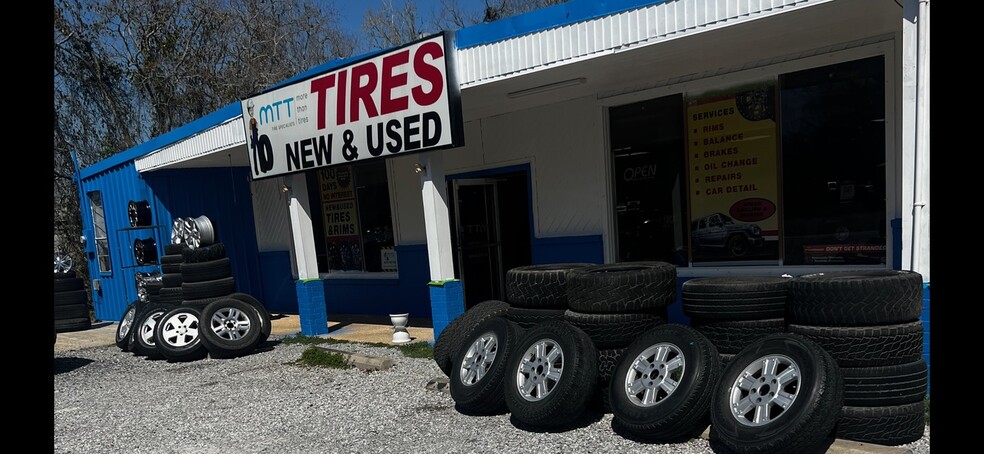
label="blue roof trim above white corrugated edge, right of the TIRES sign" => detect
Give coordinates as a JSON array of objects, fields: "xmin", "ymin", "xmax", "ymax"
[{"xmin": 455, "ymin": 0, "xmax": 667, "ymax": 49}]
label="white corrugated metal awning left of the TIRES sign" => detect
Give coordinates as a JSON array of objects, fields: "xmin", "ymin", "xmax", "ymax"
[{"xmin": 134, "ymin": 115, "xmax": 249, "ymax": 172}]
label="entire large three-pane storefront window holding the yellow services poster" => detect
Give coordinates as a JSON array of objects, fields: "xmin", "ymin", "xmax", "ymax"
[{"xmin": 609, "ymin": 57, "xmax": 886, "ymax": 266}]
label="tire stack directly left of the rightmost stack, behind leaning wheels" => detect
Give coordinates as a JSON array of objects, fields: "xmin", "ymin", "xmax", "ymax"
[{"xmin": 680, "ymin": 276, "xmax": 792, "ymax": 365}]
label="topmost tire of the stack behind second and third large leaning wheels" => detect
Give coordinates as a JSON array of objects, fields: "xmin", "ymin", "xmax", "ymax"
[{"xmin": 567, "ymin": 262, "xmax": 676, "ymax": 314}]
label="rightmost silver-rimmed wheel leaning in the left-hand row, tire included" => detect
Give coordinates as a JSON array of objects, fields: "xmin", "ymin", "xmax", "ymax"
[{"xmin": 201, "ymin": 298, "xmax": 262, "ymax": 359}]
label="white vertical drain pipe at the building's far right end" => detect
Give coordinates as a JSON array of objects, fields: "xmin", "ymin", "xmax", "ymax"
[{"xmin": 909, "ymin": 0, "xmax": 929, "ymax": 281}]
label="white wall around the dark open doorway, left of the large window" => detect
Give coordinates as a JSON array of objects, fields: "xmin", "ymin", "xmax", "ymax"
[{"xmin": 389, "ymin": 97, "xmax": 608, "ymax": 244}]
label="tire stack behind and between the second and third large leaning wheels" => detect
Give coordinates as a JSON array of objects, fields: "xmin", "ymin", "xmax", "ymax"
[{"xmin": 564, "ymin": 262, "xmax": 677, "ymax": 412}]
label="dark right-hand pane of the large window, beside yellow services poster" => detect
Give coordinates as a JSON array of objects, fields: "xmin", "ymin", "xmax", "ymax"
[{"xmin": 779, "ymin": 57, "xmax": 886, "ymax": 265}]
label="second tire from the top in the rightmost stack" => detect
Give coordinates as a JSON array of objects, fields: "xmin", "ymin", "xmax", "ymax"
[{"xmin": 787, "ymin": 320, "xmax": 923, "ymax": 367}]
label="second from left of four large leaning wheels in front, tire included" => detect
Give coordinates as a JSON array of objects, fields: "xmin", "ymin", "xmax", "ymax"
[{"xmin": 505, "ymin": 320, "xmax": 598, "ymax": 428}]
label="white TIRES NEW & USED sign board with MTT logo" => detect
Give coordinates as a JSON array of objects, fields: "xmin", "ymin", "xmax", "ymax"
[{"xmin": 242, "ymin": 33, "xmax": 464, "ymax": 179}]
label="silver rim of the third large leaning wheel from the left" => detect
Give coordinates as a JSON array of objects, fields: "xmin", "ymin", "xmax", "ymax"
[{"xmin": 623, "ymin": 342, "xmax": 687, "ymax": 407}]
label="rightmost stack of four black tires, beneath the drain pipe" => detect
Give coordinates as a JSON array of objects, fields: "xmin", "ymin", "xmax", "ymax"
[{"xmin": 786, "ymin": 270, "xmax": 928, "ymax": 445}]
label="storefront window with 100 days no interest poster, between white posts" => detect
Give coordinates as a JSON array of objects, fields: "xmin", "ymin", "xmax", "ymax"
[{"xmin": 307, "ymin": 161, "xmax": 396, "ymax": 272}]
